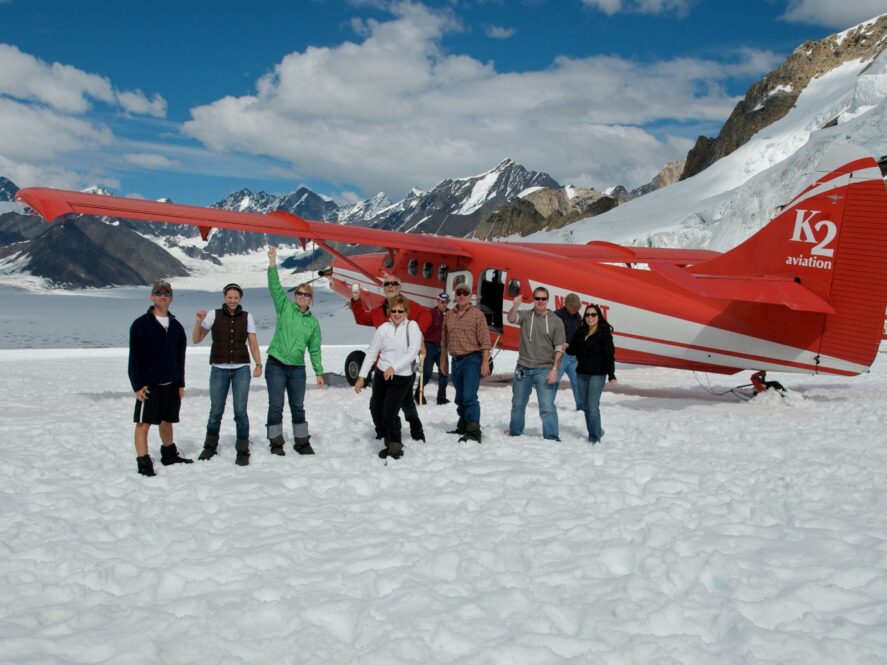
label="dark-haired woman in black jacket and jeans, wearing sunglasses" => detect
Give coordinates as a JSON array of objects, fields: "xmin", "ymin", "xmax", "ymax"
[{"xmin": 567, "ymin": 304, "xmax": 616, "ymax": 444}]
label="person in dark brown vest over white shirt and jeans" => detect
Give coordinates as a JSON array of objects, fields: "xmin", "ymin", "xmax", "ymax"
[{"xmin": 191, "ymin": 284, "xmax": 262, "ymax": 466}]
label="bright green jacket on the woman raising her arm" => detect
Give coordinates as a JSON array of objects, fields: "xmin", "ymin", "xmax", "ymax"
[{"xmin": 268, "ymin": 266, "xmax": 323, "ymax": 376}]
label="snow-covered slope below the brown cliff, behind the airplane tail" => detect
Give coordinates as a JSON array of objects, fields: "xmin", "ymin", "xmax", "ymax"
[{"xmin": 532, "ymin": 47, "xmax": 887, "ymax": 251}]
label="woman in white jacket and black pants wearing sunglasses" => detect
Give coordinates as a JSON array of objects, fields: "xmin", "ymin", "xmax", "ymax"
[{"xmin": 354, "ymin": 296, "xmax": 422, "ymax": 459}]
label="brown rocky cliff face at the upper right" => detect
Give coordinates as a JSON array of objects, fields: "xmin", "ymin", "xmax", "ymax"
[{"xmin": 681, "ymin": 16, "xmax": 887, "ymax": 180}]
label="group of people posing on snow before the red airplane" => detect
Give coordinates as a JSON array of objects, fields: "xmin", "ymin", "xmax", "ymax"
[{"xmin": 129, "ymin": 252, "xmax": 616, "ymax": 476}]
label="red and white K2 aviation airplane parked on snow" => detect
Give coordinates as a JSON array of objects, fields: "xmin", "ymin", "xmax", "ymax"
[{"xmin": 12, "ymin": 146, "xmax": 887, "ymax": 389}]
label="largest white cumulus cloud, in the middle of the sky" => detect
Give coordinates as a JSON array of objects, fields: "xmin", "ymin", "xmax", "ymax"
[{"xmin": 184, "ymin": 3, "xmax": 779, "ymax": 196}]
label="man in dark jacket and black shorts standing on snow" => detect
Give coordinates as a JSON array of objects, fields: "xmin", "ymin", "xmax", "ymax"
[{"xmin": 129, "ymin": 280, "xmax": 193, "ymax": 476}]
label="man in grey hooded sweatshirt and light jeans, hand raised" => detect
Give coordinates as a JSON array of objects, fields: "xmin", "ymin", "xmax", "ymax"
[{"xmin": 508, "ymin": 286, "xmax": 565, "ymax": 441}]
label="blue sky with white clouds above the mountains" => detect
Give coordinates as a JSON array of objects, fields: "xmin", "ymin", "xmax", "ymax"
[{"xmin": 0, "ymin": 0, "xmax": 887, "ymax": 205}]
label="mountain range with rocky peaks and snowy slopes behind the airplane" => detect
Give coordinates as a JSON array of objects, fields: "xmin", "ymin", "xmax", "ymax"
[{"xmin": 0, "ymin": 16, "xmax": 887, "ymax": 287}]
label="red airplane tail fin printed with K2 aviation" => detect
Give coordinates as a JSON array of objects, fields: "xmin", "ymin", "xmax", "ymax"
[{"xmin": 685, "ymin": 146, "xmax": 887, "ymax": 367}]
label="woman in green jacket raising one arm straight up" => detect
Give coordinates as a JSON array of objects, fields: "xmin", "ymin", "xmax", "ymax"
[{"xmin": 265, "ymin": 247, "xmax": 323, "ymax": 455}]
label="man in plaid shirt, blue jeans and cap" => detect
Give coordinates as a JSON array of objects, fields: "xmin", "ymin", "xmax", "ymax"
[{"xmin": 440, "ymin": 284, "xmax": 490, "ymax": 443}]
